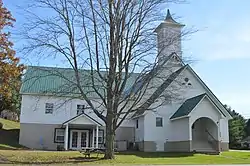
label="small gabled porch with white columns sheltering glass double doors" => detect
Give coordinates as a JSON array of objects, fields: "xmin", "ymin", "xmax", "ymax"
[{"xmin": 63, "ymin": 113, "xmax": 104, "ymax": 150}]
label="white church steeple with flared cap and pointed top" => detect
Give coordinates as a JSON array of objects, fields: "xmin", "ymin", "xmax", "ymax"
[{"xmin": 155, "ymin": 9, "xmax": 185, "ymax": 61}]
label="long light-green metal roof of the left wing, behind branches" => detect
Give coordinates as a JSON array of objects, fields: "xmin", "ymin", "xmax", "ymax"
[{"xmin": 20, "ymin": 66, "xmax": 139, "ymax": 97}]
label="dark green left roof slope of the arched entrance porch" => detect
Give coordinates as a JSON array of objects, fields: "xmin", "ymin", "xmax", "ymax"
[{"xmin": 170, "ymin": 93, "xmax": 206, "ymax": 119}]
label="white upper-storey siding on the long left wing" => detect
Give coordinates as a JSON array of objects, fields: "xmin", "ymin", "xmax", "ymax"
[{"xmin": 20, "ymin": 95, "xmax": 134, "ymax": 127}]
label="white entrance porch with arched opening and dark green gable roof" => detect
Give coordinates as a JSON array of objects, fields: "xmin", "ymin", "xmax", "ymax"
[{"xmin": 170, "ymin": 94, "xmax": 226, "ymax": 153}]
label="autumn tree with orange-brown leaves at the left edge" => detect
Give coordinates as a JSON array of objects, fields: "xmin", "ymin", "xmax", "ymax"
[{"xmin": 0, "ymin": 0, "xmax": 24, "ymax": 111}]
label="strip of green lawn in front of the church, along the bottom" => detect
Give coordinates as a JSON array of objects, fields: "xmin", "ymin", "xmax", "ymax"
[{"xmin": 0, "ymin": 150, "xmax": 250, "ymax": 165}]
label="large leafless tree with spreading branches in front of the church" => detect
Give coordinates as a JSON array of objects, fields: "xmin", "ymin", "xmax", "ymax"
[{"xmin": 19, "ymin": 0, "xmax": 190, "ymax": 159}]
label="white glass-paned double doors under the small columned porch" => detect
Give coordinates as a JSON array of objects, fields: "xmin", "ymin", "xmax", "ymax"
[{"xmin": 70, "ymin": 130, "xmax": 89, "ymax": 150}]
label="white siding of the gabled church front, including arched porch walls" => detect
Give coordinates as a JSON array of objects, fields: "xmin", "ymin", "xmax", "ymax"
[{"xmin": 139, "ymin": 66, "xmax": 228, "ymax": 151}]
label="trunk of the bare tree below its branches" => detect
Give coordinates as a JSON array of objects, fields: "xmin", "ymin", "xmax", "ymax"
[{"xmin": 104, "ymin": 113, "xmax": 115, "ymax": 159}]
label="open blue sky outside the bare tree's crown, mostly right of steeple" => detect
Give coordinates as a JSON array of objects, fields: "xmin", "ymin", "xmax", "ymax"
[{"xmin": 3, "ymin": 0, "xmax": 250, "ymax": 118}]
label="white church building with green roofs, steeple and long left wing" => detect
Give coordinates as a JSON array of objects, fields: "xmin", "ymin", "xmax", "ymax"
[{"xmin": 19, "ymin": 11, "xmax": 232, "ymax": 152}]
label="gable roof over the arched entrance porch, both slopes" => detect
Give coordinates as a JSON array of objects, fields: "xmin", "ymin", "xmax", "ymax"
[{"xmin": 170, "ymin": 93, "xmax": 226, "ymax": 120}]
